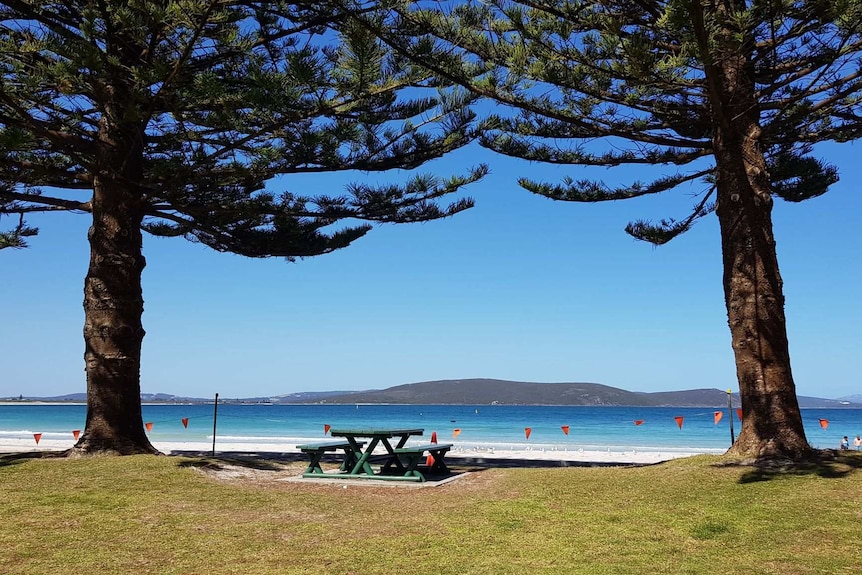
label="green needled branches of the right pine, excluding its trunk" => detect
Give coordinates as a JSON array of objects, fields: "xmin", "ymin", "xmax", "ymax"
[{"xmin": 376, "ymin": 0, "xmax": 862, "ymax": 244}]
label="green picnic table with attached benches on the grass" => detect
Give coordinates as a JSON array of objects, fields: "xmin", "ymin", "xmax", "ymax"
[{"xmin": 299, "ymin": 428, "xmax": 452, "ymax": 481}]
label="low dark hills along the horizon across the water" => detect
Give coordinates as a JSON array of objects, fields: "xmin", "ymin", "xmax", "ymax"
[{"xmin": 8, "ymin": 379, "xmax": 862, "ymax": 408}]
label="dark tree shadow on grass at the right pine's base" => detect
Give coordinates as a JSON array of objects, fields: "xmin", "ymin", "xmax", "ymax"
[{"xmin": 716, "ymin": 449, "xmax": 862, "ymax": 483}]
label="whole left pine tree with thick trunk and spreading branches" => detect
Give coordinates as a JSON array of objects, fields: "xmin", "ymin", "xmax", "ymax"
[{"xmin": 0, "ymin": 1, "xmax": 486, "ymax": 454}]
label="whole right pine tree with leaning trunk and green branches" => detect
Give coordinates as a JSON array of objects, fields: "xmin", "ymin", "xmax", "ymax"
[{"xmin": 365, "ymin": 0, "xmax": 862, "ymax": 459}]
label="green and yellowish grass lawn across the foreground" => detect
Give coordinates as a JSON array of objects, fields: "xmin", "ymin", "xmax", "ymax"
[{"xmin": 0, "ymin": 453, "xmax": 862, "ymax": 575}]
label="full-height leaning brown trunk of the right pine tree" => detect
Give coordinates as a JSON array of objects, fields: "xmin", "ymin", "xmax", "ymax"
[{"xmin": 692, "ymin": 0, "xmax": 812, "ymax": 459}]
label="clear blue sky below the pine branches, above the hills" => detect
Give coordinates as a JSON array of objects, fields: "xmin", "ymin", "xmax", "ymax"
[{"xmin": 0, "ymin": 140, "xmax": 862, "ymax": 397}]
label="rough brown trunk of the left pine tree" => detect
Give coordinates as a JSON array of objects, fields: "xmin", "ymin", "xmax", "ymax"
[{"xmin": 71, "ymin": 102, "xmax": 158, "ymax": 455}]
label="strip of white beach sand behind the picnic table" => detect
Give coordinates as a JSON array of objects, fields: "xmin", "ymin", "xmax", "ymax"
[{"xmin": 0, "ymin": 438, "xmax": 717, "ymax": 465}]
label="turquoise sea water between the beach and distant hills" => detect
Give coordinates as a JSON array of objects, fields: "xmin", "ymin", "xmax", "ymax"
[{"xmin": 0, "ymin": 404, "xmax": 862, "ymax": 453}]
